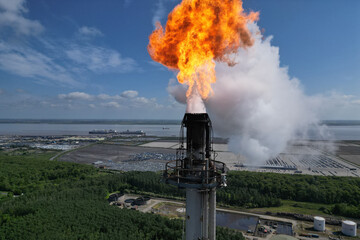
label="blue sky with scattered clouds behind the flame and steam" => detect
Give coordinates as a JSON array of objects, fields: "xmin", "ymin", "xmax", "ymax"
[{"xmin": 0, "ymin": 0, "xmax": 360, "ymax": 119}]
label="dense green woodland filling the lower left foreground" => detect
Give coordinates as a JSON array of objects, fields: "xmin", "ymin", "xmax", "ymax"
[{"xmin": 0, "ymin": 154, "xmax": 244, "ymax": 240}]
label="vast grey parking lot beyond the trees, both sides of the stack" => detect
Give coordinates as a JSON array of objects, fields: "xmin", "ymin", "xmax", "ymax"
[{"xmin": 59, "ymin": 139, "xmax": 360, "ymax": 177}]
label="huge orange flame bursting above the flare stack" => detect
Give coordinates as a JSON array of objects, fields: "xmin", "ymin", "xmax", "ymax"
[{"xmin": 148, "ymin": 0, "xmax": 259, "ymax": 99}]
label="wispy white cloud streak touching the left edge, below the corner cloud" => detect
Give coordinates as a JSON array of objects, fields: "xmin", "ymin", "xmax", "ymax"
[{"xmin": 0, "ymin": 41, "xmax": 79, "ymax": 86}]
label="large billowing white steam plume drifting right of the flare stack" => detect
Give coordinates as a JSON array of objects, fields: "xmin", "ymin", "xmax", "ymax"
[{"xmin": 168, "ymin": 23, "xmax": 323, "ymax": 163}]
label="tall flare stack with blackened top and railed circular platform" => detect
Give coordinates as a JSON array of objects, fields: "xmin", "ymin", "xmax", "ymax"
[{"xmin": 164, "ymin": 113, "xmax": 226, "ymax": 240}]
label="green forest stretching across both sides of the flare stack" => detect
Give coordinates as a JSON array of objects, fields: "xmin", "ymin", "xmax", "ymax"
[{"xmin": 0, "ymin": 149, "xmax": 360, "ymax": 239}]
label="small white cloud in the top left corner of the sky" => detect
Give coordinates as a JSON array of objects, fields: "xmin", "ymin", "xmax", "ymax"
[{"xmin": 0, "ymin": 0, "xmax": 44, "ymax": 35}]
